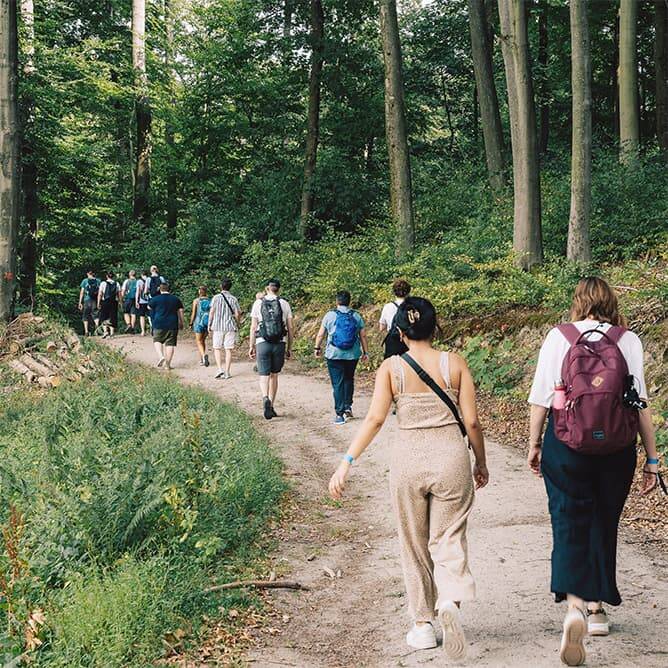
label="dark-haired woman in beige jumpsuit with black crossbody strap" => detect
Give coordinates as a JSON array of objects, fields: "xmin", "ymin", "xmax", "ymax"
[{"xmin": 329, "ymin": 297, "xmax": 489, "ymax": 659}]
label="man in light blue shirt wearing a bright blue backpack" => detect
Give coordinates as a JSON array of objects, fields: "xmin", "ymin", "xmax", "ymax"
[{"xmin": 315, "ymin": 290, "xmax": 369, "ymax": 425}]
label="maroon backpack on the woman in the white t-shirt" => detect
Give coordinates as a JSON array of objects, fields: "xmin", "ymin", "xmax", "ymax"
[{"xmin": 553, "ymin": 323, "xmax": 639, "ymax": 455}]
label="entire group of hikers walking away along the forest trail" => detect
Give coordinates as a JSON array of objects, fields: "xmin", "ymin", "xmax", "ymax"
[{"xmin": 79, "ymin": 267, "xmax": 666, "ymax": 666}]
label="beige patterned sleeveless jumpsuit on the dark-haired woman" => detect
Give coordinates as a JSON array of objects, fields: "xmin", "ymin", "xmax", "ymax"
[{"xmin": 390, "ymin": 353, "xmax": 475, "ymax": 621}]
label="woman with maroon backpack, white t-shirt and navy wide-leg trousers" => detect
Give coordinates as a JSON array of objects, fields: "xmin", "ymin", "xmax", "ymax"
[{"xmin": 528, "ymin": 278, "xmax": 663, "ymax": 666}]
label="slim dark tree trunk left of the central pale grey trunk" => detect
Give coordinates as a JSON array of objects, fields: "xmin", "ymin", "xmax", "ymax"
[{"xmin": 299, "ymin": 0, "xmax": 325, "ymax": 239}]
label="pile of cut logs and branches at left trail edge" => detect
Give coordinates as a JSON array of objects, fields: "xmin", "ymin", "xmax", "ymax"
[{"xmin": 0, "ymin": 313, "xmax": 93, "ymax": 388}]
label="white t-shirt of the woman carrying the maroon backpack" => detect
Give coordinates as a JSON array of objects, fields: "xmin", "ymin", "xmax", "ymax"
[{"xmin": 529, "ymin": 320, "xmax": 647, "ymax": 408}]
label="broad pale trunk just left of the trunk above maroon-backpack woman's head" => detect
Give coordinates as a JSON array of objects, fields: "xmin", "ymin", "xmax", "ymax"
[{"xmin": 499, "ymin": 0, "xmax": 543, "ymax": 269}]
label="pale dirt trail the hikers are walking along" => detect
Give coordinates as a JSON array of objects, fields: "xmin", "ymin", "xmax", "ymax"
[{"xmin": 113, "ymin": 337, "xmax": 668, "ymax": 668}]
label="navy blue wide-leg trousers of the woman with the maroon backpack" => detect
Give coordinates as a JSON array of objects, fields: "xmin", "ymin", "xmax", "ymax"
[{"xmin": 541, "ymin": 416, "xmax": 636, "ymax": 605}]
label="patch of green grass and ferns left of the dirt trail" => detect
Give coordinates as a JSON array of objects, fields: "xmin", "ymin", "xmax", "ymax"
[{"xmin": 0, "ymin": 346, "xmax": 285, "ymax": 667}]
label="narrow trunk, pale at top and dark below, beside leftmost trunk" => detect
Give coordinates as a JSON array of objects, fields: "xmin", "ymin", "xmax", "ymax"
[{"xmin": 19, "ymin": 0, "xmax": 39, "ymax": 308}]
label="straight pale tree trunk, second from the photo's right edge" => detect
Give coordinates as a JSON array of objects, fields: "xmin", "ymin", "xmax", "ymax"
[{"xmin": 618, "ymin": 0, "xmax": 640, "ymax": 164}]
